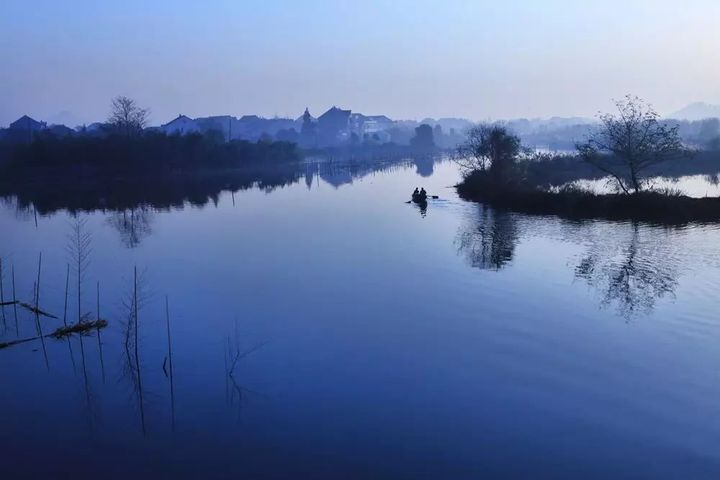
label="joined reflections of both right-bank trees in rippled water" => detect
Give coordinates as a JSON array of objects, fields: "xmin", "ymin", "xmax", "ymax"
[{"xmin": 455, "ymin": 204, "xmax": 682, "ymax": 319}]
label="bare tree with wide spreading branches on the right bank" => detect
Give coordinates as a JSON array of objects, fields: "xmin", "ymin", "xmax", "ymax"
[{"xmin": 576, "ymin": 95, "xmax": 689, "ymax": 193}]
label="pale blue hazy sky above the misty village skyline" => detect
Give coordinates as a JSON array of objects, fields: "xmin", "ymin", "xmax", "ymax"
[{"xmin": 0, "ymin": 0, "xmax": 720, "ymax": 125}]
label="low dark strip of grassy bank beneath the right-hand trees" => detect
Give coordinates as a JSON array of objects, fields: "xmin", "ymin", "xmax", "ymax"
[{"xmin": 456, "ymin": 172, "xmax": 720, "ymax": 224}]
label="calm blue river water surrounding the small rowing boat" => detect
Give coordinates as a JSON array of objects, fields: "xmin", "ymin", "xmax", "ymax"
[{"xmin": 0, "ymin": 162, "xmax": 720, "ymax": 479}]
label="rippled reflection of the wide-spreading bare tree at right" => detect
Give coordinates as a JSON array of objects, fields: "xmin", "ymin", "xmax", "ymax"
[{"xmin": 575, "ymin": 223, "xmax": 678, "ymax": 318}]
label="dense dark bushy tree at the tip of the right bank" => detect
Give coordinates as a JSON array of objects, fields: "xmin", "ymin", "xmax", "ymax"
[{"xmin": 456, "ymin": 124, "xmax": 523, "ymax": 178}]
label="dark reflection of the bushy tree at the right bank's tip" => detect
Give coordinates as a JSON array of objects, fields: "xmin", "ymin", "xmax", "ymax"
[{"xmin": 456, "ymin": 204, "xmax": 518, "ymax": 270}]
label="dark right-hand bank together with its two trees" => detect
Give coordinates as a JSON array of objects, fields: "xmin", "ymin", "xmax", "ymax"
[{"xmin": 457, "ymin": 96, "xmax": 720, "ymax": 223}]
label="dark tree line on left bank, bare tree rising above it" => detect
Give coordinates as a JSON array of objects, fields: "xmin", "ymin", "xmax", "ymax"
[{"xmin": 0, "ymin": 97, "xmax": 300, "ymax": 179}]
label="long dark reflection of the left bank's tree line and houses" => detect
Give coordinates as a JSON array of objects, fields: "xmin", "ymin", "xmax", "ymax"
[{"xmin": 0, "ymin": 156, "xmax": 443, "ymax": 212}]
